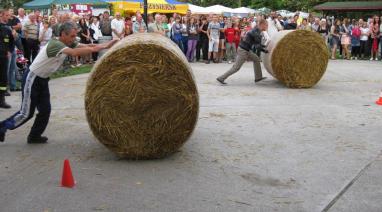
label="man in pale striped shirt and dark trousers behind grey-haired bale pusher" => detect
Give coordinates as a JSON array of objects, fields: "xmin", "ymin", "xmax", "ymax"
[{"xmin": 23, "ymin": 13, "xmax": 40, "ymax": 65}]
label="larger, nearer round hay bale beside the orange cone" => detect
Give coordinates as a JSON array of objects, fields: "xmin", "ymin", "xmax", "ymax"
[{"xmin": 85, "ymin": 34, "xmax": 199, "ymax": 159}]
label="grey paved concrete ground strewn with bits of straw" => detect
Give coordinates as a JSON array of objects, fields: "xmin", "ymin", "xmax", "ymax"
[{"xmin": 0, "ymin": 61, "xmax": 382, "ymax": 212}]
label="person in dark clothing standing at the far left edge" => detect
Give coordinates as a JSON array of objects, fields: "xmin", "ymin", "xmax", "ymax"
[{"xmin": 0, "ymin": 9, "xmax": 15, "ymax": 109}]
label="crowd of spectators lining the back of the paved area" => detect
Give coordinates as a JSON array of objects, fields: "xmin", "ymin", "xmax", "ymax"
[{"xmin": 0, "ymin": 8, "xmax": 382, "ymax": 93}]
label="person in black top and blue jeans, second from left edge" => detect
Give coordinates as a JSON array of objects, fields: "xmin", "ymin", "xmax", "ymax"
[{"xmin": 8, "ymin": 9, "xmax": 23, "ymax": 91}]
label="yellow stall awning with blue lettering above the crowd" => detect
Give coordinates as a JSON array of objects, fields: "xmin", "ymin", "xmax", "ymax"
[{"xmin": 108, "ymin": 0, "xmax": 188, "ymax": 14}]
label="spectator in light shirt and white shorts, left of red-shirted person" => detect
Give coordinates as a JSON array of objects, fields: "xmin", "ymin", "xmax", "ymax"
[{"xmin": 207, "ymin": 15, "xmax": 221, "ymax": 64}]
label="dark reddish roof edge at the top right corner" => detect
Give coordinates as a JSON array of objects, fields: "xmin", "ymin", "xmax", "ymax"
[{"xmin": 314, "ymin": 1, "xmax": 382, "ymax": 11}]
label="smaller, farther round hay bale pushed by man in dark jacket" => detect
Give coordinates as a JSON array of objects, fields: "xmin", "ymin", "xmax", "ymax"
[{"xmin": 262, "ymin": 30, "xmax": 329, "ymax": 88}]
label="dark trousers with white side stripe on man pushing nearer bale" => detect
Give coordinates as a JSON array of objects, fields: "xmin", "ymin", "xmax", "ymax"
[{"xmin": 1, "ymin": 70, "xmax": 51, "ymax": 138}]
